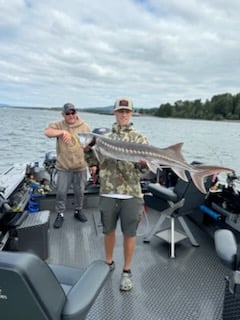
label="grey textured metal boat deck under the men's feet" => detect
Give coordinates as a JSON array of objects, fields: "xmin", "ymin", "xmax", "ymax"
[{"xmin": 42, "ymin": 197, "xmax": 229, "ymax": 320}]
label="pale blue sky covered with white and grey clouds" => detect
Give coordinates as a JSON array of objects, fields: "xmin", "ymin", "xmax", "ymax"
[{"xmin": 0, "ymin": 0, "xmax": 240, "ymax": 108}]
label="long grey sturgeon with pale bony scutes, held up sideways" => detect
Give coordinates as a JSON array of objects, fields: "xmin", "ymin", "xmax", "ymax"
[{"xmin": 78, "ymin": 132, "xmax": 234, "ymax": 193}]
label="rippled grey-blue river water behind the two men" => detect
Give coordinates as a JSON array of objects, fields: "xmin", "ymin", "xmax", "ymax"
[{"xmin": 0, "ymin": 108, "xmax": 240, "ymax": 175}]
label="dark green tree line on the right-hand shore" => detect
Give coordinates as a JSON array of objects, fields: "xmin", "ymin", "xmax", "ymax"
[{"xmin": 138, "ymin": 93, "xmax": 240, "ymax": 120}]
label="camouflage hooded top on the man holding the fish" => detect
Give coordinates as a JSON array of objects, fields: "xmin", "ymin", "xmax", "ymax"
[{"xmin": 100, "ymin": 123, "xmax": 148, "ymax": 198}]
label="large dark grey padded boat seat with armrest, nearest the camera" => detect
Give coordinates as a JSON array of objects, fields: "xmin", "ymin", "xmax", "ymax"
[{"xmin": 0, "ymin": 251, "xmax": 109, "ymax": 320}]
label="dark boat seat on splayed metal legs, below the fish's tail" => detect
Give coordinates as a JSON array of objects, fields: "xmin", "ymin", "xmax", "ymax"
[{"xmin": 143, "ymin": 173, "xmax": 207, "ymax": 258}]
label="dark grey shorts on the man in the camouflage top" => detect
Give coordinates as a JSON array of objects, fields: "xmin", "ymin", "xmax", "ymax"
[{"xmin": 100, "ymin": 197, "xmax": 143, "ymax": 237}]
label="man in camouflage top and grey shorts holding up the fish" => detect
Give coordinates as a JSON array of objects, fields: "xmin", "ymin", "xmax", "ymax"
[{"xmin": 100, "ymin": 98, "xmax": 147, "ymax": 291}]
